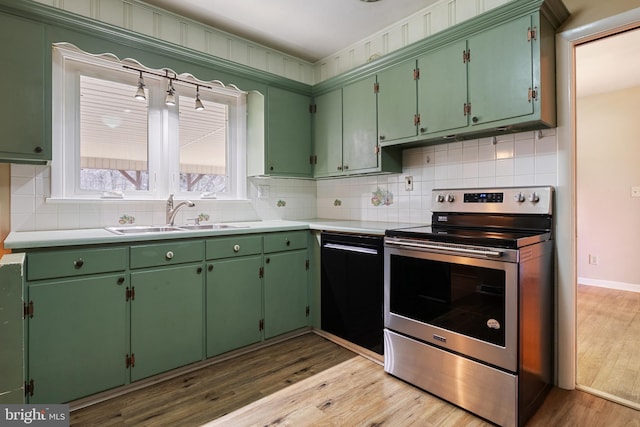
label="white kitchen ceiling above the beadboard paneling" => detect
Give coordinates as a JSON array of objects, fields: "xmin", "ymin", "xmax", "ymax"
[{"xmin": 144, "ymin": 0, "xmax": 440, "ymax": 63}]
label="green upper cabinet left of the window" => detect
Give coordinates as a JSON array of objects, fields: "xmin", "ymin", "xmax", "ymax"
[{"xmin": 0, "ymin": 13, "xmax": 51, "ymax": 163}]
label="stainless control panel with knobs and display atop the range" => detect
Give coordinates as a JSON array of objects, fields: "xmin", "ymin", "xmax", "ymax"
[{"xmin": 431, "ymin": 186, "xmax": 553, "ymax": 215}]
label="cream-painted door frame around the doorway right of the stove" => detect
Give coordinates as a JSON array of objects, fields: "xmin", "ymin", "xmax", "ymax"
[{"xmin": 555, "ymin": 8, "xmax": 640, "ymax": 390}]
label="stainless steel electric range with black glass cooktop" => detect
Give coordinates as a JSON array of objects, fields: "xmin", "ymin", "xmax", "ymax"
[{"xmin": 384, "ymin": 187, "xmax": 554, "ymax": 426}]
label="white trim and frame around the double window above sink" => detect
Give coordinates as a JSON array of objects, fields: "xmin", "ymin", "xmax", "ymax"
[{"xmin": 47, "ymin": 44, "xmax": 247, "ymax": 202}]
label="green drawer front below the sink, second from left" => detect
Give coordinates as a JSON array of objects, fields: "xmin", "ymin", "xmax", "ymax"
[{"xmin": 131, "ymin": 241, "xmax": 204, "ymax": 269}]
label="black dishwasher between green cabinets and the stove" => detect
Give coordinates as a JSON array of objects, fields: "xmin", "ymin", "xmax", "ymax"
[{"xmin": 321, "ymin": 232, "xmax": 384, "ymax": 354}]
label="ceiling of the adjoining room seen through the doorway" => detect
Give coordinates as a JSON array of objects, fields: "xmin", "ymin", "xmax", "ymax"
[{"xmin": 576, "ymin": 29, "xmax": 640, "ymax": 97}]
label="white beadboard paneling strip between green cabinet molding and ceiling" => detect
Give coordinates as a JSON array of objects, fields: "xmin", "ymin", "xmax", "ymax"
[{"xmin": 35, "ymin": 0, "xmax": 511, "ymax": 85}]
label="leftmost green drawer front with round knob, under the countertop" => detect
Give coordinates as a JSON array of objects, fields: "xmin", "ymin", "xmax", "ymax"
[{"xmin": 27, "ymin": 247, "xmax": 127, "ymax": 280}]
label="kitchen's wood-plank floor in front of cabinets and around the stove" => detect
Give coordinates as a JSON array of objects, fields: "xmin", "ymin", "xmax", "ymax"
[{"xmin": 71, "ymin": 333, "xmax": 640, "ymax": 427}]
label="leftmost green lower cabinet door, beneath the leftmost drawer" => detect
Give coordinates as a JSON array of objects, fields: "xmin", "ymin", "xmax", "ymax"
[{"xmin": 27, "ymin": 274, "xmax": 129, "ymax": 403}]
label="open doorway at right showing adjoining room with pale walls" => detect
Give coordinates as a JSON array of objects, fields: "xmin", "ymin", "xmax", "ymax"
[{"xmin": 575, "ymin": 27, "xmax": 640, "ymax": 409}]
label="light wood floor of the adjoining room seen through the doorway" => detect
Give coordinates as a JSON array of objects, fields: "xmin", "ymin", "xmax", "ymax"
[{"xmin": 577, "ymin": 285, "xmax": 640, "ymax": 405}]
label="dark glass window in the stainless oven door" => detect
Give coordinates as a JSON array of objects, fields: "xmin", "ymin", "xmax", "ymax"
[{"xmin": 389, "ymin": 255, "xmax": 505, "ymax": 347}]
